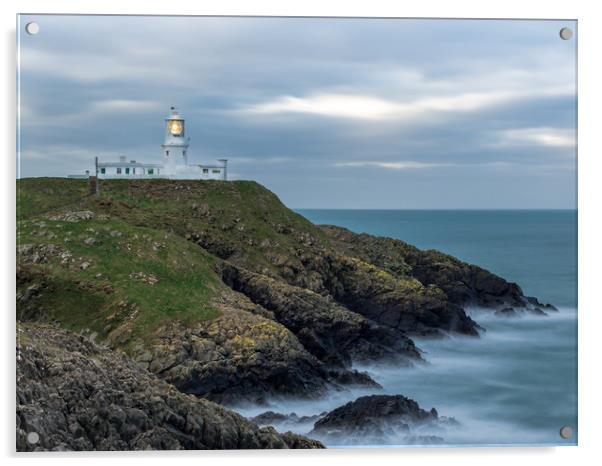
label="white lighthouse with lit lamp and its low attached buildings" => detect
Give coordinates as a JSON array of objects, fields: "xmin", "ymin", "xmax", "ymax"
[{"xmin": 69, "ymin": 107, "xmax": 228, "ymax": 180}]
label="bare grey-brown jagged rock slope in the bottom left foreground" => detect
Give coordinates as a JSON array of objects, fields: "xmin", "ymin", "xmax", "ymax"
[{"xmin": 17, "ymin": 324, "xmax": 323, "ymax": 451}]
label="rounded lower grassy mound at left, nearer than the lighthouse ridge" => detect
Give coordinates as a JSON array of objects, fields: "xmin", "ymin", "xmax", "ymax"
[{"xmin": 18, "ymin": 215, "xmax": 225, "ymax": 343}]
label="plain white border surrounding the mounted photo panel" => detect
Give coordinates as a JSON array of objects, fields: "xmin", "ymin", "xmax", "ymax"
[{"xmin": 0, "ymin": 0, "xmax": 602, "ymax": 466}]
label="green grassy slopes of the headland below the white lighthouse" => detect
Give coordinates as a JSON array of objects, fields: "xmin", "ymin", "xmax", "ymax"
[{"xmin": 17, "ymin": 178, "xmax": 324, "ymax": 346}]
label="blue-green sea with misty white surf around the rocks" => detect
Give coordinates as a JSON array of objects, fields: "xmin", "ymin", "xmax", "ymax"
[{"xmin": 229, "ymin": 209, "xmax": 578, "ymax": 447}]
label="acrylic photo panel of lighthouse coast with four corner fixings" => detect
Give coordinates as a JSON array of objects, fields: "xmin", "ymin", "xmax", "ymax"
[{"xmin": 16, "ymin": 14, "xmax": 577, "ymax": 451}]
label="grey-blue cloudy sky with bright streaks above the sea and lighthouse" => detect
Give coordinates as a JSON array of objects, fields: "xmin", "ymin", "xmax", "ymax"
[{"xmin": 20, "ymin": 16, "xmax": 576, "ymax": 209}]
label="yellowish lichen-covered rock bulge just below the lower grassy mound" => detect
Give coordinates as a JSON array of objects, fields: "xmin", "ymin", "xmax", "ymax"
[{"xmin": 134, "ymin": 311, "xmax": 338, "ymax": 403}]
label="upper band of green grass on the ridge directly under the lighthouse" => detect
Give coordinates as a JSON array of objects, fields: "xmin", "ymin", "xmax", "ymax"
[{"xmin": 17, "ymin": 178, "xmax": 328, "ymax": 274}]
